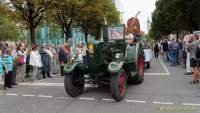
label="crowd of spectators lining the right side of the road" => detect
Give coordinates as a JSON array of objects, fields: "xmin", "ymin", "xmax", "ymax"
[{"xmin": 153, "ymin": 34, "xmax": 200, "ymax": 84}]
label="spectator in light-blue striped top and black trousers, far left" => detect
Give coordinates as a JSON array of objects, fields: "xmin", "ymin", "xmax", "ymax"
[{"xmin": 2, "ymin": 48, "xmax": 14, "ymax": 90}]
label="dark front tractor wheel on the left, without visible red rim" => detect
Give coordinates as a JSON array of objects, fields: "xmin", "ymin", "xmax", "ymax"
[{"xmin": 64, "ymin": 69, "xmax": 85, "ymax": 97}]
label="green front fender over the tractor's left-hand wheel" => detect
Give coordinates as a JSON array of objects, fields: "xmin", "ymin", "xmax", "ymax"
[{"xmin": 63, "ymin": 62, "xmax": 86, "ymax": 74}]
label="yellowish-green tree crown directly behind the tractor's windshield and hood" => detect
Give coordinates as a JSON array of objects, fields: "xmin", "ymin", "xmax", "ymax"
[{"xmin": 77, "ymin": 0, "xmax": 119, "ymax": 40}]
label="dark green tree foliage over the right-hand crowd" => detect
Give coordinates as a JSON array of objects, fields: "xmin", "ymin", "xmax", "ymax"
[{"xmin": 149, "ymin": 0, "xmax": 200, "ymax": 39}]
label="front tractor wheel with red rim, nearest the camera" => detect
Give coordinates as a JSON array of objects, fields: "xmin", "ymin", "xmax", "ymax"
[{"xmin": 110, "ymin": 69, "xmax": 127, "ymax": 102}]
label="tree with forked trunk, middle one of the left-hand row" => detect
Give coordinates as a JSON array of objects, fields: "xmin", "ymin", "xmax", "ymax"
[{"xmin": 48, "ymin": 0, "xmax": 82, "ymax": 40}]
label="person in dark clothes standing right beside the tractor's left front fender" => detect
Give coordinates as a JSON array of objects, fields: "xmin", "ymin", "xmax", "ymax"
[{"xmin": 59, "ymin": 45, "xmax": 68, "ymax": 76}]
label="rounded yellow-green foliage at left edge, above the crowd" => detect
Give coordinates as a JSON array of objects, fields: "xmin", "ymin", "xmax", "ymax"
[{"xmin": 0, "ymin": 15, "xmax": 20, "ymax": 41}]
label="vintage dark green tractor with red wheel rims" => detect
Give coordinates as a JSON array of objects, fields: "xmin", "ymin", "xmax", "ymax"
[{"xmin": 64, "ymin": 25, "xmax": 144, "ymax": 101}]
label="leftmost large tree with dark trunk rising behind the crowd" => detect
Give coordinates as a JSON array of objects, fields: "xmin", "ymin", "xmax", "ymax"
[{"xmin": 10, "ymin": 0, "xmax": 52, "ymax": 44}]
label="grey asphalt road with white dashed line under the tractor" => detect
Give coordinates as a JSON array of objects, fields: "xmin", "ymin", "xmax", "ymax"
[{"xmin": 0, "ymin": 55, "xmax": 200, "ymax": 113}]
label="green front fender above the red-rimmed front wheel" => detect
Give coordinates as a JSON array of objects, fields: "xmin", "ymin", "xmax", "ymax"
[{"xmin": 108, "ymin": 61, "xmax": 124, "ymax": 74}]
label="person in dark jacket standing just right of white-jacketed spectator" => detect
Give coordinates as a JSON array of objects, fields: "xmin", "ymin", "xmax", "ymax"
[{"xmin": 40, "ymin": 44, "xmax": 52, "ymax": 79}]
